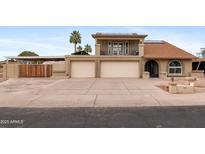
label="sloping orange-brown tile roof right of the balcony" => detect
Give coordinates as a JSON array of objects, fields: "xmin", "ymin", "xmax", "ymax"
[{"xmin": 144, "ymin": 41, "xmax": 196, "ymax": 59}]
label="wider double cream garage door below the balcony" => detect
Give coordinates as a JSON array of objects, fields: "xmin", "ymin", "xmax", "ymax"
[{"xmin": 101, "ymin": 62, "xmax": 139, "ymax": 78}]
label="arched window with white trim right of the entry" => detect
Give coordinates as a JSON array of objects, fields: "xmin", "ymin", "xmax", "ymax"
[{"xmin": 168, "ymin": 60, "xmax": 182, "ymax": 75}]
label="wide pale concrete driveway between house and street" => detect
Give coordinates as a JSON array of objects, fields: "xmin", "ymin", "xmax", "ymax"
[{"xmin": 0, "ymin": 78, "xmax": 205, "ymax": 108}]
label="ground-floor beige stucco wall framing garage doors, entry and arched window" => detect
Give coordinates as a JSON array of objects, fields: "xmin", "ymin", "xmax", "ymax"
[{"xmin": 66, "ymin": 56, "xmax": 192, "ymax": 78}]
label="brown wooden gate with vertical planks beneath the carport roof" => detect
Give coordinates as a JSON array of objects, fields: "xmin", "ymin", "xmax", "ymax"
[{"xmin": 19, "ymin": 64, "xmax": 52, "ymax": 77}]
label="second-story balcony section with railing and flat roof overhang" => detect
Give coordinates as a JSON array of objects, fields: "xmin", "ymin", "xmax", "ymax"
[{"xmin": 92, "ymin": 33, "xmax": 147, "ymax": 57}]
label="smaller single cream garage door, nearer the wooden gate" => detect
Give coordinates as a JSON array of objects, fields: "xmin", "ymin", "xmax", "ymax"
[{"xmin": 71, "ymin": 61, "xmax": 95, "ymax": 78}]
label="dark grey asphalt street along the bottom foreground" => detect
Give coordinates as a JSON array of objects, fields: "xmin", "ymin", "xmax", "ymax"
[{"xmin": 0, "ymin": 106, "xmax": 205, "ymax": 128}]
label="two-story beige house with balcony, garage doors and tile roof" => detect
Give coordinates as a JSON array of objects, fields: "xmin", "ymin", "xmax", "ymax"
[{"xmin": 66, "ymin": 33, "xmax": 196, "ymax": 78}]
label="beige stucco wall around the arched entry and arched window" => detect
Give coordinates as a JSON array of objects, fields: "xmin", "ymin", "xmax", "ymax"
[{"xmin": 143, "ymin": 59, "xmax": 192, "ymax": 76}]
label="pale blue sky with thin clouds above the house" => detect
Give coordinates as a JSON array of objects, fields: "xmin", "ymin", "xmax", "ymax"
[{"xmin": 0, "ymin": 26, "xmax": 205, "ymax": 60}]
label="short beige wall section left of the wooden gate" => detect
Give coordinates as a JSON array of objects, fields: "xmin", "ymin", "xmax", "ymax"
[{"xmin": 3, "ymin": 62, "xmax": 19, "ymax": 79}]
